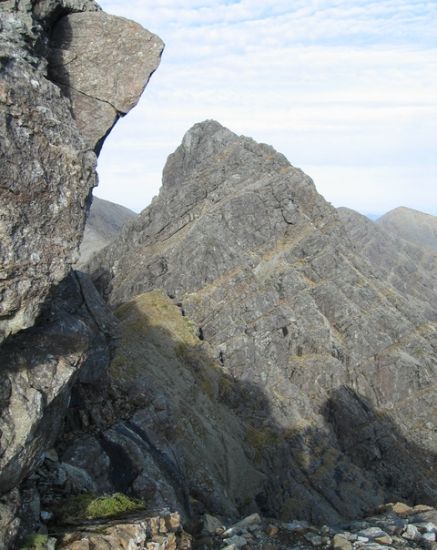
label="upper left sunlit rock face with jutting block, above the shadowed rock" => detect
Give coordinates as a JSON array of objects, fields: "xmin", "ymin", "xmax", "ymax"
[{"xmin": 0, "ymin": 0, "xmax": 162, "ymax": 342}]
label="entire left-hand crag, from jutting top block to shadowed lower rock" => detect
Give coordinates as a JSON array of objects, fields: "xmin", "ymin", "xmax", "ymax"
[{"xmin": 0, "ymin": 0, "xmax": 163, "ymax": 548}]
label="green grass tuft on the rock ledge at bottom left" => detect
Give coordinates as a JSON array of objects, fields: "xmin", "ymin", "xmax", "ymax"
[{"xmin": 59, "ymin": 493, "xmax": 144, "ymax": 523}]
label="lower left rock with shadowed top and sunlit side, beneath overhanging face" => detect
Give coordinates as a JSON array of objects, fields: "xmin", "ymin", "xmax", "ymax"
[{"xmin": 0, "ymin": 274, "xmax": 115, "ymax": 494}]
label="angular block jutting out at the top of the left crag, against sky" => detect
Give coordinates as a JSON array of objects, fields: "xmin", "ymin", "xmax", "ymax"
[{"xmin": 50, "ymin": 12, "xmax": 164, "ymax": 151}]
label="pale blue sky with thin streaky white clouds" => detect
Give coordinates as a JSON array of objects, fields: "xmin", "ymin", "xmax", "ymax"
[{"xmin": 95, "ymin": 0, "xmax": 437, "ymax": 216}]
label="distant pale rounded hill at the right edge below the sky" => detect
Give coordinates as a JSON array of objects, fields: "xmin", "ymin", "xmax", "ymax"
[{"xmin": 376, "ymin": 206, "xmax": 437, "ymax": 253}]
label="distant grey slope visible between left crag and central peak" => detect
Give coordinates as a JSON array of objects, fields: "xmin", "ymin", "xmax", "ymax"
[{"xmin": 77, "ymin": 197, "xmax": 136, "ymax": 269}]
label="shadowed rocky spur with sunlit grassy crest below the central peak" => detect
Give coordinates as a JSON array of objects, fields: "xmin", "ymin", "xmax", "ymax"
[{"xmin": 45, "ymin": 291, "xmax": 265, "ymax": 520}]
